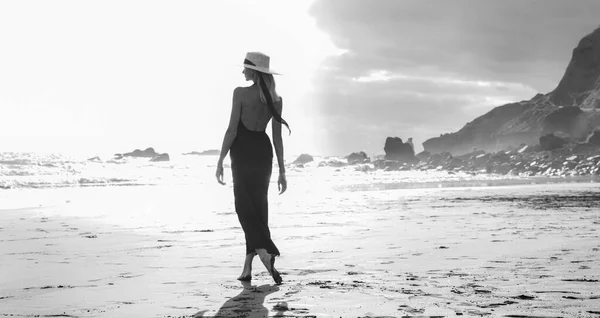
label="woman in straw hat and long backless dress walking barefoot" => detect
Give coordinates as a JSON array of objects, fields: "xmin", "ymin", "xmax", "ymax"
[{"xmin": 216, "ymin": 52, "xmax": 291, "ymax": 285}]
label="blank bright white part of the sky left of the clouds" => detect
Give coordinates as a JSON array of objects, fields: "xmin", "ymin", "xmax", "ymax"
[{"xmin": 0, "ymin": 0, "xmax": 338, "ymax": 155}]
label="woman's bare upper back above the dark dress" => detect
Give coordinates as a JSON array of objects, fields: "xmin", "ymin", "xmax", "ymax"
[{"xmin": 240, "ymin": 85, "xmax": 282, "ymax": 131}]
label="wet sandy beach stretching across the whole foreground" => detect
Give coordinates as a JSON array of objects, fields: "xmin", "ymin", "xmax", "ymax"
[{"xmin": 0, "ymin": 183, "xmax": 600, "ymax": 317}]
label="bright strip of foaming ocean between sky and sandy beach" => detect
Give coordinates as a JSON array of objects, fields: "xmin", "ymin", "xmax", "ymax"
[{"xmin": 0, "ymin": 152, "xmax": 597, "ymax": 191}]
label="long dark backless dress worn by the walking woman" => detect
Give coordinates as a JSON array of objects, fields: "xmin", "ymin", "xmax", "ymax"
[{"xmin": 229, "ymin": 119, "xmax": 279, "ymax": 255}]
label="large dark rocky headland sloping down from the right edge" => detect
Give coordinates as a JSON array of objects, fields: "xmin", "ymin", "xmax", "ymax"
[{"xmin": 423, "ymin": 28, "xmax": 600, "ymax": 155}]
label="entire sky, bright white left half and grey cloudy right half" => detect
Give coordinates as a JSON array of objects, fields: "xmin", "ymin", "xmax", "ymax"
[{"xmin": 0, "ymin": 0, "xmax": 600, "ymax": 155}]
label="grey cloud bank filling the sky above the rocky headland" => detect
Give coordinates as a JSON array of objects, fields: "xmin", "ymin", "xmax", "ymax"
[{"xmin": 310, "ymin": 0, "xmax": 600, "ymax": 153}]
